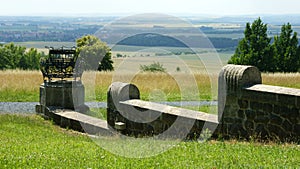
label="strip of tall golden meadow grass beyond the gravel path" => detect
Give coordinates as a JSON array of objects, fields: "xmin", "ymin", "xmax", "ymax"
[{"xmin": 0, "ymin": 70, "xmax": 300, "ymax": 102}]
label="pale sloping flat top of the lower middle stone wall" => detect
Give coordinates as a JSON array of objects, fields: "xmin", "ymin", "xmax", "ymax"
[{"xmin": 120, "ymin": 99, "xmax": 218, "ymax": 124}]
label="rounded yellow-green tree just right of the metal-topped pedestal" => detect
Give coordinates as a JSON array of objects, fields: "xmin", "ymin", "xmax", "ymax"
[{"xmin": 76, "ymin": 35, "xmax": 113, "ymax": 71}]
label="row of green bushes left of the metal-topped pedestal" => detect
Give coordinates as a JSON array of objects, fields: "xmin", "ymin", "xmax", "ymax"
[{"xmin": 0, "ymin": 43, "xmax": 43, "ymax": 70}]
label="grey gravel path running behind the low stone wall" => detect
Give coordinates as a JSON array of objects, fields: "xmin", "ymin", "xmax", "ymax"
[{"xmin": 0, "ymin": 101, "xmax": 218, "ymax": 113}]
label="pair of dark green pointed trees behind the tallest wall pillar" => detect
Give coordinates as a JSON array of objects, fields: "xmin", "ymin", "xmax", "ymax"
[{"xmin": 228, "ymin": 18, "xmax": 300, "ymax": 72}]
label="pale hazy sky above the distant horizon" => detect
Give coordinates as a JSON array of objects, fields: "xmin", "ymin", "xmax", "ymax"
[{"xmin": 0, "ymin": 0, "xmax": 300, "ymax": 16}]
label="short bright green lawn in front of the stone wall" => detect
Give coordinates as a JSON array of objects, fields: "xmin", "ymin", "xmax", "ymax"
[{"xmin": 0, "ymin": 115, "xmax": 300, "ymax": 168}]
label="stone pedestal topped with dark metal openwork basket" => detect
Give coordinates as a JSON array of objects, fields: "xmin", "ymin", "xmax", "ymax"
[{"xmin": 36, "ymin": 47, "xmax": 88, "ymax": 115}]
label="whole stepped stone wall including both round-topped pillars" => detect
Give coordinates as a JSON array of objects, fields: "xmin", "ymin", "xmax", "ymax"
[{"xmin": 107, "ymin": 65, "xmax": 300, "ymax": 142}]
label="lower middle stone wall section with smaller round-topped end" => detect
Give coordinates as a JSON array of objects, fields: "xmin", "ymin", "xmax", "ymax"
[{"xmin": 107, "ymin": 82, "xmax": 218, "ymax": 139}]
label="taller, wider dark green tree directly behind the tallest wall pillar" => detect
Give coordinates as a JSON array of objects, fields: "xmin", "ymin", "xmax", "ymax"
[{"xmin": 228, "ymin": 18, "xmax": 275, "ymax": 72}]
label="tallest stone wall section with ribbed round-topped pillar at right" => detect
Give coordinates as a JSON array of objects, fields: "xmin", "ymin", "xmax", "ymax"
[{"xmin": 218, "ymin": 65, "xmax": 300, "ymax": 142}]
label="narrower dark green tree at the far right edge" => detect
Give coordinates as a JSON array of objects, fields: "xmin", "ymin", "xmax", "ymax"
[{"xmin": 273, "ymin": 23, "xmax": 300, "ymax": 72}]
